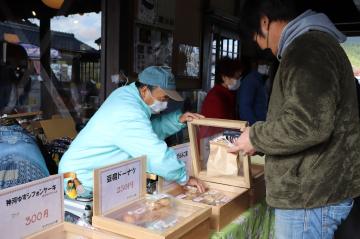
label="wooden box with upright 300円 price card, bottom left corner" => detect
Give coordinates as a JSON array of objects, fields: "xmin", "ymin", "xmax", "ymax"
[{"xmin": 0, "ymin": 175, "xmax": 126, "ymax": 239}]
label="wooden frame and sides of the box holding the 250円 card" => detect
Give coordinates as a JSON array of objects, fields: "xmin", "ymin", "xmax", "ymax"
[{"xmin": 92, "ymin": 157, "xmax": 211, "ymax": 239}]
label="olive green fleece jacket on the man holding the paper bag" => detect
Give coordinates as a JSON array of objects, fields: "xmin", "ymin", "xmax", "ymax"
[{"xmin": 250, "ymin": 31, "xmax": 360, "ymax": 208}]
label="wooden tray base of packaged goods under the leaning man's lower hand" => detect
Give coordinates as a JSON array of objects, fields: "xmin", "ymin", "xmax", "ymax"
[{"xmin": 168, "ymin": 182, "xmax": 250, "ymax": 231}]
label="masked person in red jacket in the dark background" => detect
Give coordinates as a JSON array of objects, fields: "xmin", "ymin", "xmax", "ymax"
[{"xmin": 200, "ymin": 57, "xmax": 243, "ymax": 138}]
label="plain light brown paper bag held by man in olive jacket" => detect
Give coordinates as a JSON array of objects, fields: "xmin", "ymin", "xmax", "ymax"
[{"xmin": 207, "ymin": 138, "xmax": 240, "ymax": 177}]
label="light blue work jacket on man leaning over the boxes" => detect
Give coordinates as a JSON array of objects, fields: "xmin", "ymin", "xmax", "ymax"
[{"xmin": 59, "ymin": 83, "xmax": 188, "ymax": 190}]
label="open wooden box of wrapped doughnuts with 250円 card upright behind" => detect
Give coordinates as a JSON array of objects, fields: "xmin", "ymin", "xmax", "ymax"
[{"xmin": 92, "ymin": 157, "xmax": 211, "ymax": 239}]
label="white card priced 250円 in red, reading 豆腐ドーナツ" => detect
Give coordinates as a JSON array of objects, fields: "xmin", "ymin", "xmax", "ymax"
[{"xmin": 95, "ymin": 158, "xmax": 145, "ymax": 213}]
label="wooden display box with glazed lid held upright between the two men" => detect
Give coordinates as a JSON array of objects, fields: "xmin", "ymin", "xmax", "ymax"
[{"xmin": 180, "ymin": 118, "xmax": 265, "ymax": 231}]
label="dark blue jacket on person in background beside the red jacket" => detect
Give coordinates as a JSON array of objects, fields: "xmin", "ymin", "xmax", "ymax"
[{"xmin": 236, "ymin": 70, "xmax": 267, "ymax": 125}]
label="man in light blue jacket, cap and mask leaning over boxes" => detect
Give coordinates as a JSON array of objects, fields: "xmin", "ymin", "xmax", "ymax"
[{"xmin": 59, "ymin": 66, "xmax": 204, "ymax": 196}]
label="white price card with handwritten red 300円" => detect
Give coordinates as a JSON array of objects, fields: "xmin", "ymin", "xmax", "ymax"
[{"xmin": 0, "ymin": 175, "xmax": 64, "ymax": 239}]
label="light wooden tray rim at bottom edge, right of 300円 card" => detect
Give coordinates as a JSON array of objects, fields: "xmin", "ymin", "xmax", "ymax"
[{"xmin": 26, "ymin": 222, "xmax": 128, "ymax": 239}]
